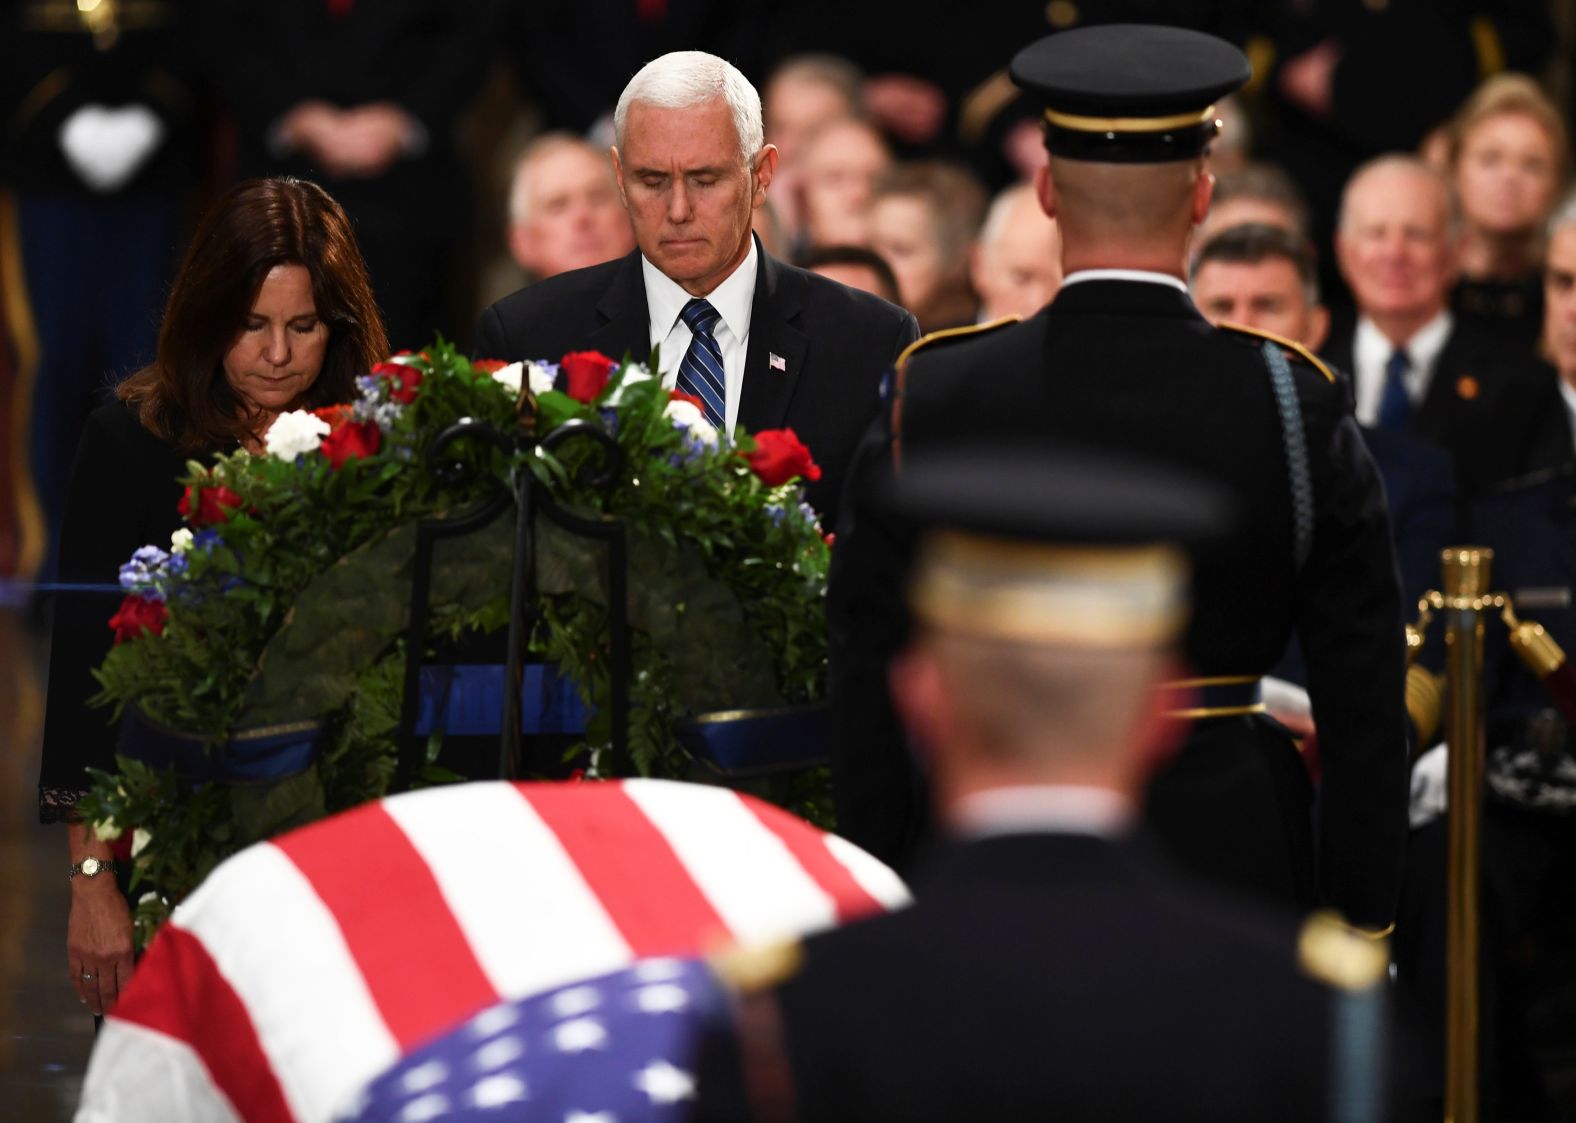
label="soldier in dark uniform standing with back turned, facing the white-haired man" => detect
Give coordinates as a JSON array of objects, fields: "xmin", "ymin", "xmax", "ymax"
[{"xmin": 827, "ymin": 25, "xmax": 1407, "ymax": 931}]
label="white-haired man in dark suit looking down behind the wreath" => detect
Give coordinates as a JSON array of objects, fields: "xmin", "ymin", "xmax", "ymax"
[{"xmin": 476, "ymin": 50, "xmax": 919, "ymax": 526}]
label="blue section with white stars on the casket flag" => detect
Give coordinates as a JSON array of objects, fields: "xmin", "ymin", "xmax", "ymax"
[{"xmin": 342, "ymin": 959, "xmax": 728, "ymax": 1123}]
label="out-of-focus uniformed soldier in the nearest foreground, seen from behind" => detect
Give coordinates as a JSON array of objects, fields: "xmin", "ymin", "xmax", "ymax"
[{"xmin": 698, "ymin": 449, "xmax": 1388, "ymax": 1123}]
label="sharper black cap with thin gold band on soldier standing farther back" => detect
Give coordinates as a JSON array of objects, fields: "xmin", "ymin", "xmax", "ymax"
[{"xmin": 1012, "ymin": 24, "xmax": 1251, "ymax": 164}]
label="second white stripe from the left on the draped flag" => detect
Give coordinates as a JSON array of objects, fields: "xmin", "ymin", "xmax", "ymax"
[{"xmin": 172, "ymin": 843, "xmax": 399, "ymax": 1123}]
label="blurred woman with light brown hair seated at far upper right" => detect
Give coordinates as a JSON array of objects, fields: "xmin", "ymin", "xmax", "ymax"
[{"xmin": 1448, "ymin": 74, "xmax": 1570, "ymax": 353}]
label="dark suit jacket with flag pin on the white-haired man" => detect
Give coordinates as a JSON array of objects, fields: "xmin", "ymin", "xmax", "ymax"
[{"xmin": 476, "ymin": 244, "xmax": 919, "ymax": 529}]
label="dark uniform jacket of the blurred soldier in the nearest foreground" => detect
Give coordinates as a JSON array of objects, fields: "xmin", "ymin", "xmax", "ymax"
[{"xmin": 756, "ymin": 833, "xmax": 1361, "ymax": 1123}]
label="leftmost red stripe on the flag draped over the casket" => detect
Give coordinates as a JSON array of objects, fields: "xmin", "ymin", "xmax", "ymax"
[{"xmin": 113, "ymin": 925, "xmax": 295, "ymax": 1123}]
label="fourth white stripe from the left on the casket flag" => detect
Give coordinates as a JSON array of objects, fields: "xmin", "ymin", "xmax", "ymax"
[{"xmin": 624, "ymin": 780, "xmax": 837, "ymax": 943}]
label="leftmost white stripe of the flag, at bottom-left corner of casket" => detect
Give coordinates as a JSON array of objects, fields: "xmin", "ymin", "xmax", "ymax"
[{"xmin": 74, "ymin": 1014, "xmax": 241, "ymax": 1123}]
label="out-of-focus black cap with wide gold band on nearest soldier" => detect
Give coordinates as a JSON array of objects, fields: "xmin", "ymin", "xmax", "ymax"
[{"xmin": 884, "ymin": 446, "xmax": 1229, "ymax": 650}]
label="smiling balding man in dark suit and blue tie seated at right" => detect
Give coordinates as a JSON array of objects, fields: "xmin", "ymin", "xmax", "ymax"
[{"xmin": 1324, "ymin": 156, "xmax": 1546, "ymax": 499}]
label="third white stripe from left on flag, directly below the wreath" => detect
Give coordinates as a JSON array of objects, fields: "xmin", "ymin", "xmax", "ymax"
[{"xmin": 383, "ymin": 783, "xmax": 632, "ymax": 999}]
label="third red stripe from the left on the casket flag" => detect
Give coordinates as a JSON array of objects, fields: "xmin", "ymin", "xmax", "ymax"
[{"xmin": 515, "ymin": 784, "xmax": 730, "ymax": 959}]
